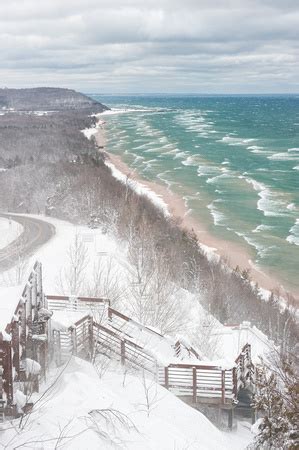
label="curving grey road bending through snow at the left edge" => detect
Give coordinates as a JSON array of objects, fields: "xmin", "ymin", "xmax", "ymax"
[{"xmin": 0, "ymin": 213, "xmax": 55, "ymax": 272}]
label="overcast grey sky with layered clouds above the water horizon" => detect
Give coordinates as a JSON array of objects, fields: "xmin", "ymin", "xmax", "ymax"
[{"xmin": 0, "ymin": 0, "xmax": 299, "ymax": 93}]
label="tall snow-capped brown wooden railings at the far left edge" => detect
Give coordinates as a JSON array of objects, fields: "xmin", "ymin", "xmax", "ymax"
[{"xmin": 0, "ymin": 261, "xmax": 46, "ymax": 416}]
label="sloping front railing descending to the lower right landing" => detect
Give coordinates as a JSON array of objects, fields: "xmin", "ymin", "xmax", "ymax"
[{"xmin": 93, "ymin": 322, "xmax": 157, "ymax": 373}]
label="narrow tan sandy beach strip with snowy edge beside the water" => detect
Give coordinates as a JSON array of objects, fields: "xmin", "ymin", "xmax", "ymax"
[{"xmin": 95, "ymin": 127, "xmax": 299, "ymax": 302}]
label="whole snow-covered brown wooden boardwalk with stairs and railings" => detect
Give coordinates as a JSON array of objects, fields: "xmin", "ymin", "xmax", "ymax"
[{"xmin": 0, "ymin": 262, "xmax": 254, "ymax": 418}]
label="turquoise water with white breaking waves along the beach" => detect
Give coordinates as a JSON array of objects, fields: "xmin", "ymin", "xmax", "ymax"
[{"xmin": 94, "ymin": 95, "xmax": 299, "ymax": 289}]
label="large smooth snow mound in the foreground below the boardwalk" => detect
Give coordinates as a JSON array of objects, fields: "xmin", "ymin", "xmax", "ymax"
[{"xmin": 1, "ymin": 357, "xmax": 248, "ymax": 450}]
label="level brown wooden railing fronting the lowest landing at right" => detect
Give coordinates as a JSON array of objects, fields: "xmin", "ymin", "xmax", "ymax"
[{"xmin": 159, "ymin": 364, "xmax": 235, "ymax": 405}]
